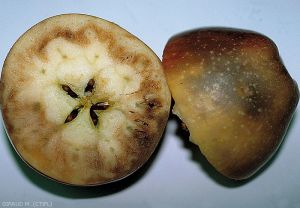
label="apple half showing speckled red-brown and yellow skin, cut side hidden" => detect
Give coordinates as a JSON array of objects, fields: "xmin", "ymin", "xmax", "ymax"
[{"xmin": 163, "ymin": 28, "xmax": 299, "ymax": 180}]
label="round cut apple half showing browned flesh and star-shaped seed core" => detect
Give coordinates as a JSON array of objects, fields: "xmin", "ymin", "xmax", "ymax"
[{"xmin": 0, "ymin": 14, "xmax": 170, "ymax": 185}]
